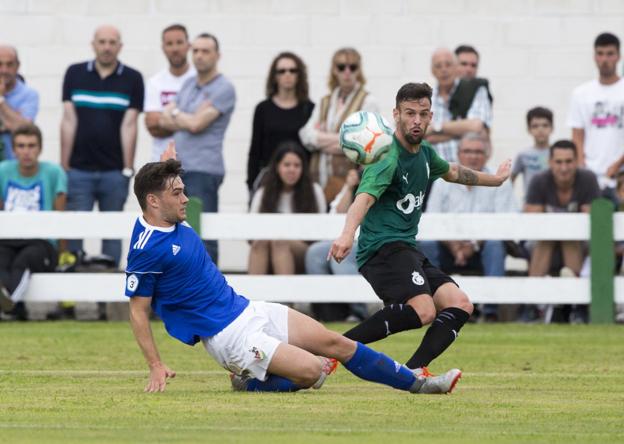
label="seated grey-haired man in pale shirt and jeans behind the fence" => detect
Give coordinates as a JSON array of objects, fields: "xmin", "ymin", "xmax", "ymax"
[{"xmin": 420, "ymin": 133, "xmax": 517, "ymax": 320}]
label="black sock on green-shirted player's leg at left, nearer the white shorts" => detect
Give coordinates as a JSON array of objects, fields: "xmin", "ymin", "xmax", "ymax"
[{"xmin": 344, "ymin": 304, "xmax": 422, "ymax": 344}]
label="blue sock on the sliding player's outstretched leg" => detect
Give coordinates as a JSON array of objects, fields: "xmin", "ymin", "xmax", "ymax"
[{"xmin": 343, "ymin": 342, "xmax": 416, "ymax": 390}]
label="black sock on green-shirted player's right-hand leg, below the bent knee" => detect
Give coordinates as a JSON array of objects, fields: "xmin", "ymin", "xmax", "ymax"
[{"xmin": 405, "ymin": 307, "xmax": 470, "ymax": 368}]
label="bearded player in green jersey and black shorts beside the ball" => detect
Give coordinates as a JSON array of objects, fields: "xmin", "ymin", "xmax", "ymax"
[{"xmin": 329, "ymin": 83, "xmax": 511, "ymax": 382}]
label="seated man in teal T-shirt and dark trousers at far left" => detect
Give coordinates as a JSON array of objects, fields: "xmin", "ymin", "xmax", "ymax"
[{"xmin": 0, "ymin": 123, "xmax": 67, "ymax": 320}]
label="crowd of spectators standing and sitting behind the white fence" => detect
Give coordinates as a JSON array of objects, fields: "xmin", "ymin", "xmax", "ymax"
[{"xmin": 0, "ymin": 24, "xmax": 624, "ymax": 321}]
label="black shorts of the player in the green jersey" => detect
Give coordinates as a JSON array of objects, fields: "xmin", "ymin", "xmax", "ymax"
[{"xmin": 360, "ymin": 242, "xmax": 459, "ymax": 305}]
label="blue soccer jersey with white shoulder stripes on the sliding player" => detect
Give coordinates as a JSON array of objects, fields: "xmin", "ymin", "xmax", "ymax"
[{"xmin": 126, "ymin": 216, "xmax": 249, "ymax": 345}]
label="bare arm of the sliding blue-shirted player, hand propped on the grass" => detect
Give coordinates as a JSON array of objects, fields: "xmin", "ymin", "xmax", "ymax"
[{"xmin": 130, "ymin": 296, "xmax": 175, "ymax": 392}]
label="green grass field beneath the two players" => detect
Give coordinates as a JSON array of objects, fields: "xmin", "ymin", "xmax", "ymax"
[{"xmin": 0, "ymin": 322, "xmax": 624, "ymax": 444}]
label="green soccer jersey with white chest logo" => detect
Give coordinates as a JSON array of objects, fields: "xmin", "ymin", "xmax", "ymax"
[{"xmin": 357, "ymin": 137, "xmax": 449, "ymax": 267}]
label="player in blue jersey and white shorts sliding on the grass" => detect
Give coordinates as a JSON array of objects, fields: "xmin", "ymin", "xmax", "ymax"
[{"xmin": 125, "ymin": 146, "xmax": 461, "ymax": 393}]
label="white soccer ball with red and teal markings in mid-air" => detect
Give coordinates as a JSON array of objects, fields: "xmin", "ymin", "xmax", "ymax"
[{"xmin": 340, "ymin": 111, "xmax": 393, "ymax": 165}]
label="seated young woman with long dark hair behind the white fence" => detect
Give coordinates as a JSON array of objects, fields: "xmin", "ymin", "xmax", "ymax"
[{"xmin": 248, "ymin": 142, "xmax": 327, "ymax": 274}]
